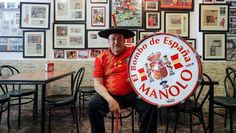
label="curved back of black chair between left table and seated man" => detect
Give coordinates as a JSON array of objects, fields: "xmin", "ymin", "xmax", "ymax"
[{"xmin": 73, "ymin": 67, "xmax": 85, "ymax": 101}]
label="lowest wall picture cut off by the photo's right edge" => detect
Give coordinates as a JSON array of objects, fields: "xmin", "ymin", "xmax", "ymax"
[{"xmin": 226, "ymin": 36, "xmax": 236, "ymax": 61}]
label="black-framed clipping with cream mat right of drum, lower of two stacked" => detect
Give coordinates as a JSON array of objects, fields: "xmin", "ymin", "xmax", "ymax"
[{"xmin": 203, "ymin": 33, "xmax": 226, "ymax": 60}]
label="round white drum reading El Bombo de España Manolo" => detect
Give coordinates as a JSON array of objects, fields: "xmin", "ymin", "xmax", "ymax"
[{"xmin": 129, "ymin": 33, "xmax": 202, "ymax": 106}]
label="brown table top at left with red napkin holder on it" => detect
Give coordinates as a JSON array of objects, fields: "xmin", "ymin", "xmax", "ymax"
[{"xmin": 0, "ymin": 70, "xmax": 75, "ymax": 84}]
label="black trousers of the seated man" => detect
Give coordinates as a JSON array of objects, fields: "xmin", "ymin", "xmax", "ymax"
[{"xmin": 88, "ymin": 92, "xmax": 157, "ymax": 133}]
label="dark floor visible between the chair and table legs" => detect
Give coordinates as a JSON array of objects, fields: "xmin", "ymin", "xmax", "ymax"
[{"xmin": 0, "ymin": 104, "xmax": 235, "ymax": 133}]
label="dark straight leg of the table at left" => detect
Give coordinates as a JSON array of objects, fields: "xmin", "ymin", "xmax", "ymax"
[{"xmin": 41, "ymin": 84, "xmax": 46, "ymax": 133}]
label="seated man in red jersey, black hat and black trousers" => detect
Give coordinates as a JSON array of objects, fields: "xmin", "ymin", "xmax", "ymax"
[{"xmin": 88, "ymin": 28, "xmax": 157, "ymax": 133}]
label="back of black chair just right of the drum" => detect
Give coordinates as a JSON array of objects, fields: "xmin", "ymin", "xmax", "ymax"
[{"xmin": 194, "ymin": 73, "xmax": 212, "ymax": 108}]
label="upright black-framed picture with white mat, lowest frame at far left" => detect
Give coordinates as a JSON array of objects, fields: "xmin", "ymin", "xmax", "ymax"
[{"xmin": 23, "ymin": 30, "xmax": 46, "ymax": 58}]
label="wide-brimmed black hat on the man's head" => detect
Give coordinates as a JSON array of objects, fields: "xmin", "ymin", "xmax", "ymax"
[{"xmin": 98, "ymin": 28, "xmax": 135, "ymax": 39}]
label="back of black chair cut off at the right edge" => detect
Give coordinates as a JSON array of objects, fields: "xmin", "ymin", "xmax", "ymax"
[{"xmin": 224, "ymin": 70, "xmax": 236, "ymax": 98}]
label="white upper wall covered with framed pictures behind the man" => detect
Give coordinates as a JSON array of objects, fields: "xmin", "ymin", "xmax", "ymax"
[{"xmin": 0, "ymin": 0, "xmax": 236, "ymax": 61}]
